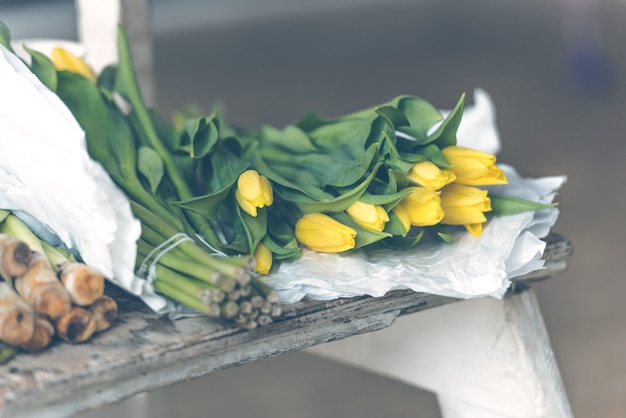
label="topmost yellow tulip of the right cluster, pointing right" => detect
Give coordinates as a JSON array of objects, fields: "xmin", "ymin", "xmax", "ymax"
[{"xmin": 441, "ymin": 146, "xmax": 507, "ymax": 186}]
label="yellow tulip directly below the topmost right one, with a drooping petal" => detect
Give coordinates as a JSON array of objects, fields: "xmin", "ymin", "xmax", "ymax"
[{"xmin": 441, "ymin": 184, "xmax": 491, "ymax": 236}]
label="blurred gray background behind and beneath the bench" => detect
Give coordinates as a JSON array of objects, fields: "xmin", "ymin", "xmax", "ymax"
[{"xmin": 0, "ymin": 0, "xmax": 626, "ymax": 418}]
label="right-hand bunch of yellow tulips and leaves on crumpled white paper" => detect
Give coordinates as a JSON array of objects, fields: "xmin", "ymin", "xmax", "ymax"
[{"xmin": 230, "ymin": 96, "xmax": 549, "ymax": 264}]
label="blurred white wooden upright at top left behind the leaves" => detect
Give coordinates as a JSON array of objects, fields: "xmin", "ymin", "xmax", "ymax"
[{"xmin": 75, "ymin": 0, "xmax": 155, "ymax": 105}]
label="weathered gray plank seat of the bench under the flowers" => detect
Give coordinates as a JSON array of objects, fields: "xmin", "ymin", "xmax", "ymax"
[{"xmin": 0, "ymin": 234, "xmax": 572, "ymax": 418}]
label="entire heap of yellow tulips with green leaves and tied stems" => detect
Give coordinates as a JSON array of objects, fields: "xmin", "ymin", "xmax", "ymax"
[{"xmin": 0, "ymin": 21, "xmax": 549, "ymax": 327}]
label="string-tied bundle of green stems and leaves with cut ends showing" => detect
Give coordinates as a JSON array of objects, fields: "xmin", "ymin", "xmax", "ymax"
[{"xmin": 46, "ymin": 27, "xmax": 281, "ymax": 328}]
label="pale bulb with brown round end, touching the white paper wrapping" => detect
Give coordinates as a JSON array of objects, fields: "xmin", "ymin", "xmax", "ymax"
[{"xmin": 59, "ymin": 261, "xmax": 104, "ymax": 306}]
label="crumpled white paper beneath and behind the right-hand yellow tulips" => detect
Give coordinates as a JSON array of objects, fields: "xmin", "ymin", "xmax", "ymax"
[{"xmin": 266, "ymin": 89, "xmax": 566, "ymax": 303}]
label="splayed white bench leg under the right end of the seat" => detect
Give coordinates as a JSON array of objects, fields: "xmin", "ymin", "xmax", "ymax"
[{"xmin": 307, "ymin": 290, "xmax": 572, "ymax": 418}]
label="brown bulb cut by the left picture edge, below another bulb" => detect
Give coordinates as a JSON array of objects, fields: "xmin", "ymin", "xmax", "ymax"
[{"xmin": 0, "ymin": 282, "xmax": 35, "ymax": 345}]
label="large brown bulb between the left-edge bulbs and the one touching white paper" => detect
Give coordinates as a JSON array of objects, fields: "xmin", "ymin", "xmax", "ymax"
[{"xmin": 15, "ymin": 252, "xmax": 72, "ymax": 320}]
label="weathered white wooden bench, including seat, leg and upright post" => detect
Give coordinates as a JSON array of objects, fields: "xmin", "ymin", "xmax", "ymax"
[{"xmin": 0, "ymin": 0, "xmax": 572, "ymax": 418}]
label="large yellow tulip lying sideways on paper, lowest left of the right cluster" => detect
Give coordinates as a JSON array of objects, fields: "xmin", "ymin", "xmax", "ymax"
[{"xmin": 296, "ymin": 213, "xmax": 356, "ymax": 253}]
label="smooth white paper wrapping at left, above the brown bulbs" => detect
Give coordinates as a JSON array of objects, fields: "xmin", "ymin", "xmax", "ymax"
[{"xmin": 0, "ymin": 45, "xmax": 168, "ymax": 311}]
